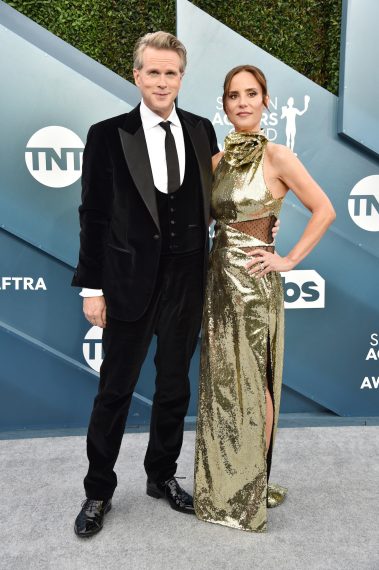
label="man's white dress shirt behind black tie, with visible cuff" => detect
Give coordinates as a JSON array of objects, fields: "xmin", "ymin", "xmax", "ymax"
[{"xmin": 79, "ymin": 99, "xmax": 186, "ymax": 297}]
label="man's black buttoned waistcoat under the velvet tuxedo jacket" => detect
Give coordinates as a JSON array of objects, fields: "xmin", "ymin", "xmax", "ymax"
[{"xmin": 155, "ymin": 126, "xmax": 204, "ymax": 255}]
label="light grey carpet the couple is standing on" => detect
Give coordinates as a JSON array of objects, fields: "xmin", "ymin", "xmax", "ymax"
[{"xmin": 0, "ymin": 426, "xmax": 379, "ymax": 570}]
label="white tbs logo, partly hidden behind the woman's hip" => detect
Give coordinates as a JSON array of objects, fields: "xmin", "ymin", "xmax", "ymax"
[{"xmin": 281, "ymin": 269, "xmax": 325, "ymax": 309}]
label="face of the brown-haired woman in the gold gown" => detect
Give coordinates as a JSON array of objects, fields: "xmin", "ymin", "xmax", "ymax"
[{"xmin": 225, "ymin": 71, "xmax": 268, "ymax": 131}]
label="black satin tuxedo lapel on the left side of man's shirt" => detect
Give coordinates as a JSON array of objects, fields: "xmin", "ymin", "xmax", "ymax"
[{"xmin": 118, "ymin": 105, "xmax": 160, "ymax": 230}]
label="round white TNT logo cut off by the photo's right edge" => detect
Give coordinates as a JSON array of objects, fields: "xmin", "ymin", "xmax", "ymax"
[{"xmin": 348, "ymin": 174, "xmax": 379, "ymax": 232}]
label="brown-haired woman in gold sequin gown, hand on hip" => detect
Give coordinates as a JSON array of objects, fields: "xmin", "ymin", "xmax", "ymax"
[{"xmin": 194, "ymin": 65, "xmax": 335, "ymax": 532}]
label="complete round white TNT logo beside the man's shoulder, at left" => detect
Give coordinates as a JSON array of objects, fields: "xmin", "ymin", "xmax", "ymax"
[{"xmin": 25, "ymin": 127, "xmax": 84, "ymax": 188}]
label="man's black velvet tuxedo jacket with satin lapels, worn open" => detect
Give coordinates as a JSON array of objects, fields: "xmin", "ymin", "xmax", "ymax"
[{"xmin": 72, "ymin": 106, "xmax": 218, "ymax": 321}]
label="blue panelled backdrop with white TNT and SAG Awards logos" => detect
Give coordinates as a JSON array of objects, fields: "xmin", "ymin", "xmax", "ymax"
[{"xmin": 0, "ymin": 0, "xmax": 379, "ymax": 431}]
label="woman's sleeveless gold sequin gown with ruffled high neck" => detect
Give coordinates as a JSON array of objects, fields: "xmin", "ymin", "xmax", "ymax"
[{"xmin": 194, "ymin": 132, "xmax": 286, "ymax": 532}]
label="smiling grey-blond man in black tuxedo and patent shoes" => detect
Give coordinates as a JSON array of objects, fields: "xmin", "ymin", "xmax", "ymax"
[{"xmin": 73, "ymin": 32, "xmax": 219, "ymax": 537}]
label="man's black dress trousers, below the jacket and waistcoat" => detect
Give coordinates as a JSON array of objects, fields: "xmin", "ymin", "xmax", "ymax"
[{"xmin": 84, "ymin": 251, "xmax": 204, "ymax": 500}]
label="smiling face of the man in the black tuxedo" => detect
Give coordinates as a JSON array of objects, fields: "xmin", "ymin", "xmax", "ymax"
[{"xmin": 133, "ymin": 47, "xmax": 183, "ymax": 119}]
